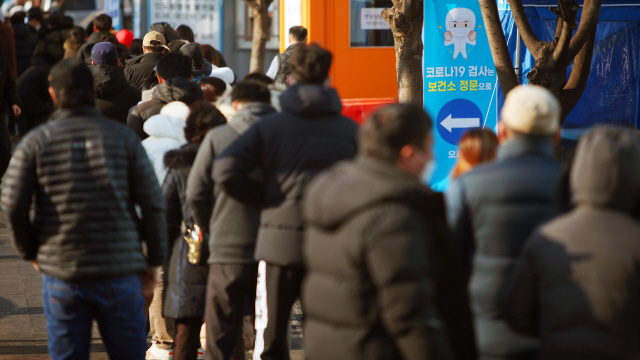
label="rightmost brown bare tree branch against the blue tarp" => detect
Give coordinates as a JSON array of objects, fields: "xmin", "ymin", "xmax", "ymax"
[{"xmin": 560, "ymin": 26, "xmax": 596, "ymax": 121}]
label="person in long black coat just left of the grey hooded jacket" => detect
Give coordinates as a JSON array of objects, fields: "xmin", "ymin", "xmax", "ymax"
[{"xmin": 162, "ymin": 100, "xmax": 228, "ymax": 360}]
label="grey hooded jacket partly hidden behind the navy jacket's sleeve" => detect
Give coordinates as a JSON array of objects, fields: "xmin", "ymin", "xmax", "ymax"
[{"xmin": 187, "ymin": 102, "xmax": 276, "ymax": 264}]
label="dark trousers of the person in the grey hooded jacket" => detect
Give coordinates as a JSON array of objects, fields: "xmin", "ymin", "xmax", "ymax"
[{"xmin": 205, "ymin": 264, "xmax": 258, "ymax": 360}]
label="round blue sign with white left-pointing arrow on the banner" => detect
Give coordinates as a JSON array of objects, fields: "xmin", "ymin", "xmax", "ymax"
[{"xmin": 437, "ymin": 99, "xmax": 484, "ymax": 145}]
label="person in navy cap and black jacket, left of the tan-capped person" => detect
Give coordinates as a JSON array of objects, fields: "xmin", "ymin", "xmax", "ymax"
[{"xmin": 89, "ymin": 42, "xmax": 142, "ymax": 125}]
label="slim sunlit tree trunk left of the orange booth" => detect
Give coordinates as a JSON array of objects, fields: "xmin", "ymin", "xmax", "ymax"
[{"xmin": 244, "ymin": 0, "xmax": 273, "ymax": 73}]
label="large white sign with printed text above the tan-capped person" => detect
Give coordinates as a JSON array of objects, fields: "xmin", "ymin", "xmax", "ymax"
[{"xmin": 149, "ymin": 0, "xmax": 221, "ymax": 49}]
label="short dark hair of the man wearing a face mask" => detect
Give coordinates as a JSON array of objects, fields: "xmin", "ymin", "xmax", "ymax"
[{"xmin": 360, "ymin": 104, "xmax": 431, "ymax": 163}]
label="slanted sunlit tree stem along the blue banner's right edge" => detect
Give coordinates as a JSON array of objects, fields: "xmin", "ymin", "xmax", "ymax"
[{"xmin": 479, "ymin": 0, "xmax": 520, "ymax": 97}]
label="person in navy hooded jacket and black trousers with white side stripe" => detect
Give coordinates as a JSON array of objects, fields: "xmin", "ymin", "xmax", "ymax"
[{"xmin": 213, "ymin": 45, "xmax": 358, "ymax": 360}]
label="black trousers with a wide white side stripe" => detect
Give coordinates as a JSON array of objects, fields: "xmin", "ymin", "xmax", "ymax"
[{"xmin": 254, "ymin": 261, "xmax": 304, "ymax": 360}]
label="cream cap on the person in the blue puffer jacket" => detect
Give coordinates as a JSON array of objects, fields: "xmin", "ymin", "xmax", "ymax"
[{"xmin": 500, "ymin": 85, "xmax": 561, "ymax": 136}]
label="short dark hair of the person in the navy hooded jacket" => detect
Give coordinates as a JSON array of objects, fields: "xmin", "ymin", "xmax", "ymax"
[{"xmin": 289, "ymin": 44, "xmax": 333, "ymax": 85}]
